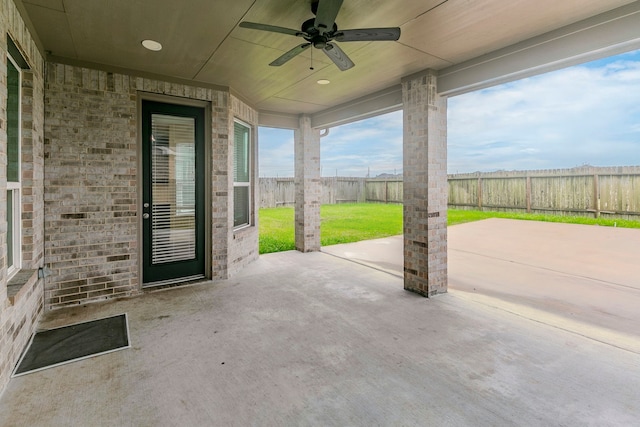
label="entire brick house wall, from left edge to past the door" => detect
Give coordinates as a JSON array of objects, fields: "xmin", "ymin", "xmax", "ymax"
[{"xmin": 0, "ymin": 0, "xmax": 258, "ymax": 393}]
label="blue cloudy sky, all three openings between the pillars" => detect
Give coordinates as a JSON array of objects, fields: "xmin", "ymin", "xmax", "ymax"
[{"xmin": 258, "ymin": 50, "xmax": 640, "ymax": 177}]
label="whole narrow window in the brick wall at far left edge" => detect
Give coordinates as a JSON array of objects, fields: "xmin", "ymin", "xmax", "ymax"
[{"xmin": 7, "ymin": 55, "xmax": 22, "ymax": 276}]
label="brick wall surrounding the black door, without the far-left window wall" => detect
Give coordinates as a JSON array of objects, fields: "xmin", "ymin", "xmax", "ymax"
[{"xmin": 45, "ymin": 63, "xmax": 257, "ymax": 308}]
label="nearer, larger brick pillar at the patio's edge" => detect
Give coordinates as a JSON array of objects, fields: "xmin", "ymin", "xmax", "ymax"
[{"xmin": 402, "ymin": 70, "xmax": 448, "ymax": 297}]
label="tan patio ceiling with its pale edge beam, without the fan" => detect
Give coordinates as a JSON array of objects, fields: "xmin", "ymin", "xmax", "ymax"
[{"xmin": 17, "ymin": 0, "xmax": 640, "ymax": 127}]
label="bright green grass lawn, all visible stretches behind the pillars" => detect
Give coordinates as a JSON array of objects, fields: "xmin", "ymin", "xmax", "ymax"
[{"xmin": 259, "ymin": 203, "xmax": 640, "ymax": 254}]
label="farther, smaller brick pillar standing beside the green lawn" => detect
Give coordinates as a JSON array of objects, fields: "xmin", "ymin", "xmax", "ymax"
[{"xmin": 294, "ymin": 115, "xmax": 322, "ymax": 252}]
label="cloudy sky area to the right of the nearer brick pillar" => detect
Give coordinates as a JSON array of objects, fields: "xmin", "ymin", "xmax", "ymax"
[{"xmin": 448, "ymin": 53, "xmax": 640, "ymax": 172}]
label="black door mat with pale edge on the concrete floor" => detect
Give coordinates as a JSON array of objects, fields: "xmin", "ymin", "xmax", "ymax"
[{"xmin": 13, "ymin": 313, "xmax": 130, "ymax": 377}]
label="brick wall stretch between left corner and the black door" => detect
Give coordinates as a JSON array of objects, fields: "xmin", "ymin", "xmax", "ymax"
[{"xmin": 45, "ymin": 63, "xmax": 138, "ymax": 308}]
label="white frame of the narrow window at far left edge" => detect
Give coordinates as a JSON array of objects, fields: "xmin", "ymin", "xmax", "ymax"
[{"xmin": 5, "ymin": 54, "xmax": 22, "ymax": 278}]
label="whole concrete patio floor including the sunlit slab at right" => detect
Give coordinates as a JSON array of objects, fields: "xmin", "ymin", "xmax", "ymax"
[{"xmin": 0, "ymin": 220, "xmax": 640, "ymax": 426}]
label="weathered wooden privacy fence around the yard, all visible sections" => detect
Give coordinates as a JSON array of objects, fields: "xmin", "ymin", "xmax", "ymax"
[{"xmin": 259, "ymin": 166, "xmax": 640, "ymax": 220}]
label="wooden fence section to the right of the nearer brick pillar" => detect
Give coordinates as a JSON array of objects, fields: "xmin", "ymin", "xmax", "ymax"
[{"xmin": 449, "ymin": 166, "xmax": 640, "ymax": 220}]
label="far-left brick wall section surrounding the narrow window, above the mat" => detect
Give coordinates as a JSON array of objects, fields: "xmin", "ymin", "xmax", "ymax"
[{"xmin": 0, "ymin": 0, "xmax": 44, "ymax": 394}]
